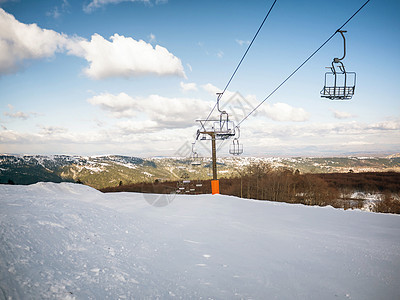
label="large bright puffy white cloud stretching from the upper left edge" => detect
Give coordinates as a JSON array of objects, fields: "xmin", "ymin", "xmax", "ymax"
[{"xmin": 0, "ymin": 8, "xmax": 185, "ymax": 79}]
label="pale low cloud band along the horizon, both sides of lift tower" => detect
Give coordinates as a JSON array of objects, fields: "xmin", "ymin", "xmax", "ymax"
[{"xmin": 0, "ymin": 117, "xmax": 400, "ymax": 156}]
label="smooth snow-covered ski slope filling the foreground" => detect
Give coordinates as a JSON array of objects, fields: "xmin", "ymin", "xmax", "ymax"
[{"xmin": 0, "ymin": 183, "xmax": 400, "ymax": 299}]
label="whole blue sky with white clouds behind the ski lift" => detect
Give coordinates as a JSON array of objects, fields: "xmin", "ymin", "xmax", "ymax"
[{"xmin": 0, "ymin": 0, "xmax": 400, "ymax": 157}]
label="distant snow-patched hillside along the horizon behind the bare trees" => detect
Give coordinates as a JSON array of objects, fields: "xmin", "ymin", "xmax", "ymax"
[{"xmin": 0, "ymin": 155, "xmax": 400, "ymax": 189}]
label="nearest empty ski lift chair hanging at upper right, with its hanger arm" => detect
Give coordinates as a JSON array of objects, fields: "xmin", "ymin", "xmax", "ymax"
[{"xmin": 320, "ymin": 30, "xmax": 356, "ymax": 100}]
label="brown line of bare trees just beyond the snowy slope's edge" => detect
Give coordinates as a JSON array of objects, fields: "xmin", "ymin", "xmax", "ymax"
[{"xmin": 102, "ymin": 162, "xmax": 400, "ymax": 214}]
